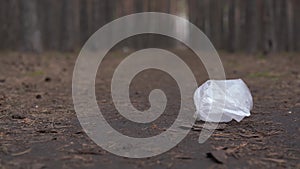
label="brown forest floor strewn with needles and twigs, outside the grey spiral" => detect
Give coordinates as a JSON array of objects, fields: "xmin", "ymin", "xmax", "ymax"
[{"xmin": 0, "ymin": 51, "xmax": 300, "ymax": 169}]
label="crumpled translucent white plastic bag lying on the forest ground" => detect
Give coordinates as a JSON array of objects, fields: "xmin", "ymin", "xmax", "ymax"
[{"xmin": 194, "ymin": 79, "xmax": 253, "ymax": 122}]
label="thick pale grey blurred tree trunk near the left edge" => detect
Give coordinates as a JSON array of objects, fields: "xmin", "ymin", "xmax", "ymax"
[{"xmin": 20, "ymin": 0, "xmax": 43, "ymax": 52}]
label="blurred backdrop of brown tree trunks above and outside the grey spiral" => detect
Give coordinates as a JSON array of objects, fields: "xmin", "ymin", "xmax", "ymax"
[{"xmin": 0, "ymin": 0, "xmax": 300, "ymax": 54}]
